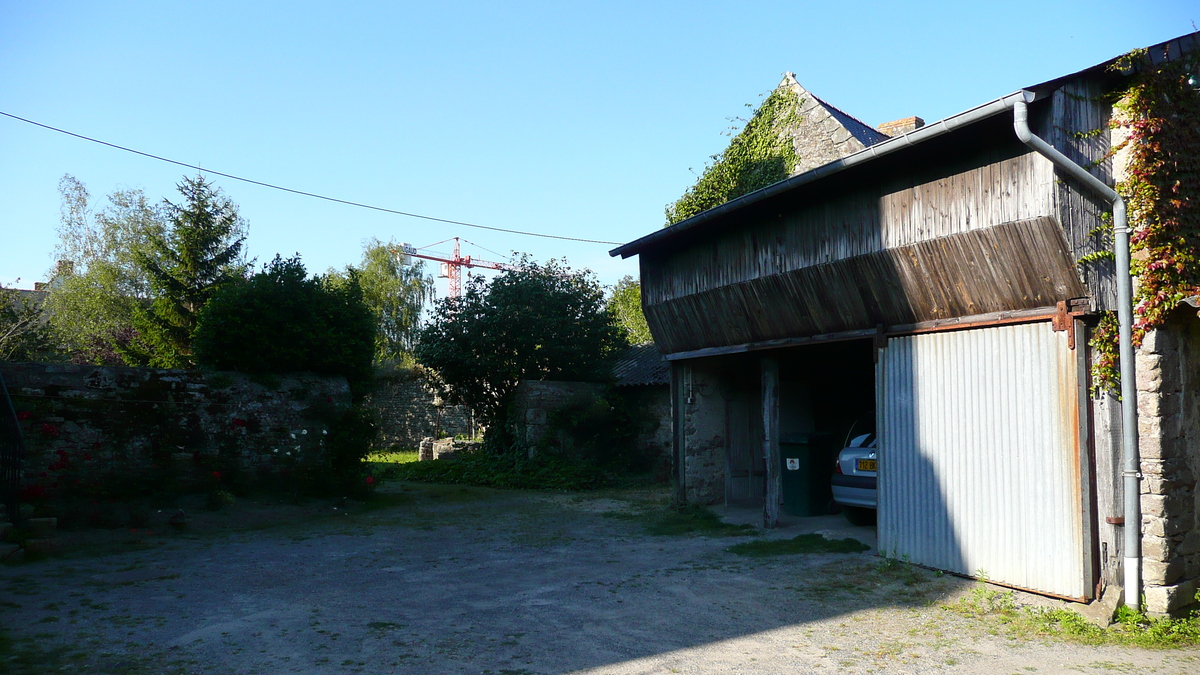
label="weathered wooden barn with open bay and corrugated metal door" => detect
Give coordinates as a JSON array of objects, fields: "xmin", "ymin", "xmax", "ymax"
[{"xmin": 612, "ymin": 34, "xmax": 1200, "ymax": 613}]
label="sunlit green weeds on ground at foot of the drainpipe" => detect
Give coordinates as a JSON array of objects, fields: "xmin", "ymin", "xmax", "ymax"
[{"xmin": 946, "ymin": 581, "xmax": 1200, "ymax": 649}]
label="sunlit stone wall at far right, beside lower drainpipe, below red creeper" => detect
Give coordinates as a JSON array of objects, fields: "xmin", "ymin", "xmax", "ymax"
[{"xmin": 1136, "ymin": 310, "xmax": 1200, "ymax": 614}]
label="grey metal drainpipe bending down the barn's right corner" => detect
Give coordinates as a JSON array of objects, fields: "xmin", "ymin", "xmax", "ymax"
[{"xmin": 1013, "ymin": 101, "xmax": 1141, "ymax": 610}]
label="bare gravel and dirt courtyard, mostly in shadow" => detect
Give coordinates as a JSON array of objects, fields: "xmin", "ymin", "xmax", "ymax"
[{"xmin": 0, "ymin": 486, "xmax": 1200, "ymax": 675}]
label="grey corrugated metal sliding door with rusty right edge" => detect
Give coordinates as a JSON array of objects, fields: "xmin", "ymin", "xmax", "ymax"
[{"xmin": 877, "ymin": 323, "xmax": 1091, "ymax": 598}]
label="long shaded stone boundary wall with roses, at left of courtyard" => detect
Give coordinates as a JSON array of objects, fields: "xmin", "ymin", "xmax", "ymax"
[{"xmin": 0, "ymin": 363, "xmax": 350, "ymax": 501}]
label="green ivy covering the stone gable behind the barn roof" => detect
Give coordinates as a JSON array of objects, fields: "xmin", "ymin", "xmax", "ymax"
[{"xmin": 666, "ymin": 85, "xmax": 800, "ymax": 226}]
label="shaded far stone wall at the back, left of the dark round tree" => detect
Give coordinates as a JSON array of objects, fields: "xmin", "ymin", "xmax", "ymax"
[{"xmin": 365, "ymin": 371, "xmax": 480, "ymax": 449}]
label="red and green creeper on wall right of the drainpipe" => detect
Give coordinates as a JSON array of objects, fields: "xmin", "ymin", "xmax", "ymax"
[{"xmin": 1091, "ymin": 49, "xmax": 1200, "ymax": 390}]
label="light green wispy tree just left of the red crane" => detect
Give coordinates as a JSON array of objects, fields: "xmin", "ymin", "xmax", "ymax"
[{"xmin": 328, "ymin": 239, "xmax": 433, "ymax": 363}]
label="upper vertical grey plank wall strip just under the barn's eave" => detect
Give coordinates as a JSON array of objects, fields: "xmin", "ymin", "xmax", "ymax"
[{"xmin": 642, "ymin": 151, "xmax": 1054, "ymax": 305}]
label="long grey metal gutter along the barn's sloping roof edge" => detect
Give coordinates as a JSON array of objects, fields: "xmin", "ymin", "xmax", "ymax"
[{"xmin": 608, "ymin": 89, "xmax": 1040, "ymax": 258}]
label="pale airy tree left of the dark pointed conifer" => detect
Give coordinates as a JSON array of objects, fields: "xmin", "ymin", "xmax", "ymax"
[{"xmin": 43, "ymin": 174, "xmax": 166, "ymax": 364}]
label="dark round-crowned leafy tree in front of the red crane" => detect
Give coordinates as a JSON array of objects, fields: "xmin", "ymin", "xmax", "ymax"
[{"xmin": 415, "ymin": 258, "xmax": 620, "ymax": 431}]
